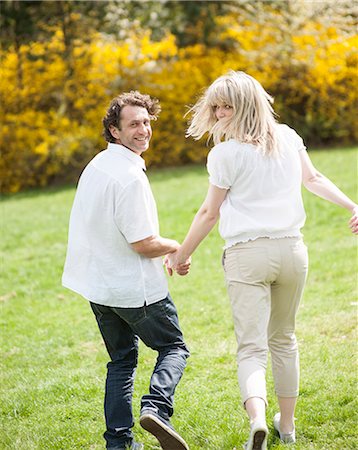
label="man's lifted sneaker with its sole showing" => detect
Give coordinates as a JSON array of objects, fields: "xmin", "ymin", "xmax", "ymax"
[{"xmin": 139, "ymin": 409, "xmax": 189, "ymax": 450}]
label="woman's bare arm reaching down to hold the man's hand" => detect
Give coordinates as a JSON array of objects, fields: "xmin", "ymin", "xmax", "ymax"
[{"xmin": 168, "ymin": 184, "xmax": 227, "ymax": 268}]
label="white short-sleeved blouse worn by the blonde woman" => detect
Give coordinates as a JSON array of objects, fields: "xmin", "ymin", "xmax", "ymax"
[{"xmin": 207, "ymin": 125, "xmax": 306, "ymax": 248}]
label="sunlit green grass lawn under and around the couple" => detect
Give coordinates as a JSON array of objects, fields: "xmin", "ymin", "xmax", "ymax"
[{"xmin": 0, "ymin": 149, "xmax": 358, "ymax": 450}]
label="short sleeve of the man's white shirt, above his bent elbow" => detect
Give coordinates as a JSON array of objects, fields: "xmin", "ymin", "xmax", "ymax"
[{"xmin": 114, "ymin": 179, "xmax": 158, "ymax": 244}]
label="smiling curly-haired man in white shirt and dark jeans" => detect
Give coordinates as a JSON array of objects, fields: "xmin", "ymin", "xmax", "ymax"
[{"xmin": 62, "ymin": 91, "xmax": 190, "ymax": 450}]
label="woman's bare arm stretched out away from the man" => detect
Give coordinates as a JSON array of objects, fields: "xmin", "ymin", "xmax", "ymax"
[{"xmin": 300, "ymin": 150, "xmax": 358, "ymax": 234}]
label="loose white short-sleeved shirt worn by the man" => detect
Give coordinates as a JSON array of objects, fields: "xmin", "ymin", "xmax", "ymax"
[{"xmin": 62, "ymin": 144, "xmax": 168, "ymax": 308}]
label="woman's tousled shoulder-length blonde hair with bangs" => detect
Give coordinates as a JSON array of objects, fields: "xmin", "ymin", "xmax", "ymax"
[{"xmin": 186, "ymin": 70, "xmax": 278, "ymax": 155}]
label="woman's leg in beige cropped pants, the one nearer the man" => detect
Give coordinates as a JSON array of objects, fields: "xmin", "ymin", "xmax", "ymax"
[{"xmin": 224, "ymin": 240, "xmax": 270, "ymax": 414}]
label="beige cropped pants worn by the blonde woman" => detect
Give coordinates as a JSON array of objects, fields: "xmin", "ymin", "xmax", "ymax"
[{"xmin": 223, "ymin": 238, "xmax": 308, "ymax": 404}]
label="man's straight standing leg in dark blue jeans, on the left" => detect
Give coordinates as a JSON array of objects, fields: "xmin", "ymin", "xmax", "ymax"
[{"xmin": 91, "ymin": 303, "xmax": 138, "ymax": 448}]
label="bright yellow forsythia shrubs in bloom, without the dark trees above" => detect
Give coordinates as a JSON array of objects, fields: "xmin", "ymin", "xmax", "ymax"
[{"xmin": 0, "ymin": 16, "xmax": 357, "ymax": 192}]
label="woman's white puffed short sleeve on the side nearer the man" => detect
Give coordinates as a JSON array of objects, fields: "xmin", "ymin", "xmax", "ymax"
[{"xmin": 206, "ymin": 142, "xmax": 236, "ymax": 189}]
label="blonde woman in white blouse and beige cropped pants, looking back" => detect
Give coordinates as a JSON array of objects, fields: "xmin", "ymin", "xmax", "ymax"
[{"xmin": 166, "ymin": 71, "xmax": 358, "ymax": 450}]
